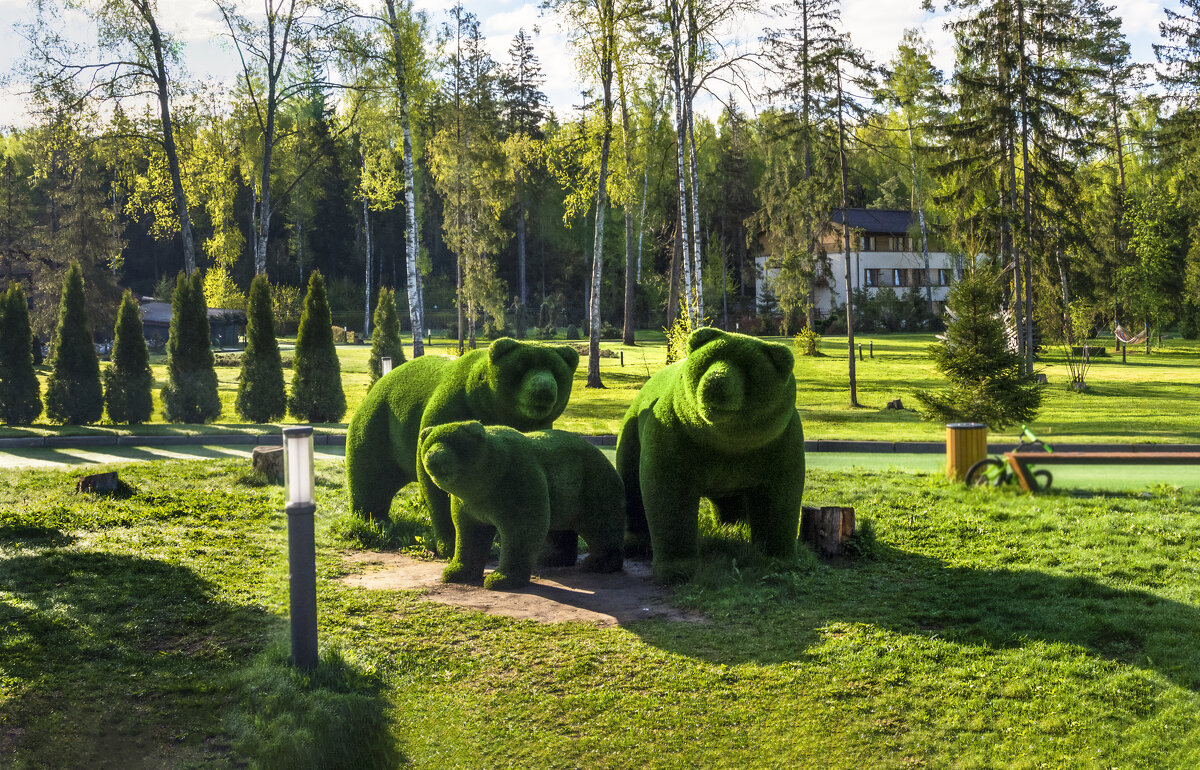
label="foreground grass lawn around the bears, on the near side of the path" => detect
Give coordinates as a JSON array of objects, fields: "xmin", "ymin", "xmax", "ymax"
[{"xmin": 0, "ymin": 455, "xmax": 1200, "ymax": 768}]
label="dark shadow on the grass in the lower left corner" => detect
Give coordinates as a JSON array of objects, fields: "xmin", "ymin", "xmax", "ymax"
[{"xmin": 0, "ymin": 549, "xmax": 402, "ymax": 768}]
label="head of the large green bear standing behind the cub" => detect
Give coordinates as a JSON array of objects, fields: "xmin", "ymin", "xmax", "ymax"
[{"xmin": 478, "ymin": 337, "xmax": 580, "ymax": 431}]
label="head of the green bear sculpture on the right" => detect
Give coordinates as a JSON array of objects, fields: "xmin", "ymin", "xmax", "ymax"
[{"xmin": 680, "ymin": 327, "xmax": 796, "ymax": 449}]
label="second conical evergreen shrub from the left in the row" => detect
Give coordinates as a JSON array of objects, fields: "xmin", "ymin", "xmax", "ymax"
[{"xmin": 46, "ymin": 261, "xmax": 104, "ymax": 425}]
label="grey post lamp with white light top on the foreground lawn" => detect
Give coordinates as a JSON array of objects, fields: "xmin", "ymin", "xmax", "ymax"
[{"xmin": 283, "ymin": 426, "xmax": 317, "ymax": 668}]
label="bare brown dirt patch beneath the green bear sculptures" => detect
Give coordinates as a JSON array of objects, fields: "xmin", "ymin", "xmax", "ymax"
[{"xmin": 341, "ymin": 551, "xmax": 708, "ymax": 626}]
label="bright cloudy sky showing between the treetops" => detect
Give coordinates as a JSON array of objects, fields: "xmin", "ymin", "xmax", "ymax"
[{"xmin": 0, "ymin": 0, "xmax": 1177, "ymax": 126}]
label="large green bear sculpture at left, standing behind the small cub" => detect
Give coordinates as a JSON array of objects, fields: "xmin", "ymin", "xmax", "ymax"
[{"xmin": 346, "ymin": 337, "xmax": 580, "ymax": 553}]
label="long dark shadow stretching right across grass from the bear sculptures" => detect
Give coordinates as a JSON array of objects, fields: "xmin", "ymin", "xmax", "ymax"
[{"xmin": 631, "ymin": 545, "xmax": 1200, "ymax": 692}]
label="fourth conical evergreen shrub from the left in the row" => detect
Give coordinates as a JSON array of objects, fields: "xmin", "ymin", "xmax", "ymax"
[{"xmin": 162, "ymin": 270, "xmax": 221, "ymax": 422}]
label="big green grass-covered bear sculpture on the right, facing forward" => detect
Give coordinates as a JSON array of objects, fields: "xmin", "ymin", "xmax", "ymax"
[{"xmin": 617, "ymin": 327, "xmax": 804, "ymax": 582}]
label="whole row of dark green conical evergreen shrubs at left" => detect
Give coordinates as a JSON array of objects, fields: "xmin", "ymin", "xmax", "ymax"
[{"xmin": 0, "ymin": 263, "xmax": 404, "ymax": 425}]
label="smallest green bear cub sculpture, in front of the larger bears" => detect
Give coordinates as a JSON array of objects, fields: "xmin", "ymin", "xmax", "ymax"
[{"xmin": 420, "ymin": 421, "xmax": 625, "ymax": 589}]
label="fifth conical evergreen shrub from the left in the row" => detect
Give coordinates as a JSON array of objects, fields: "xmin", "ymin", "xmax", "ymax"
[{"xmin": 235, "ymin": 273, "xmax": 287, "ymax": 422}]
